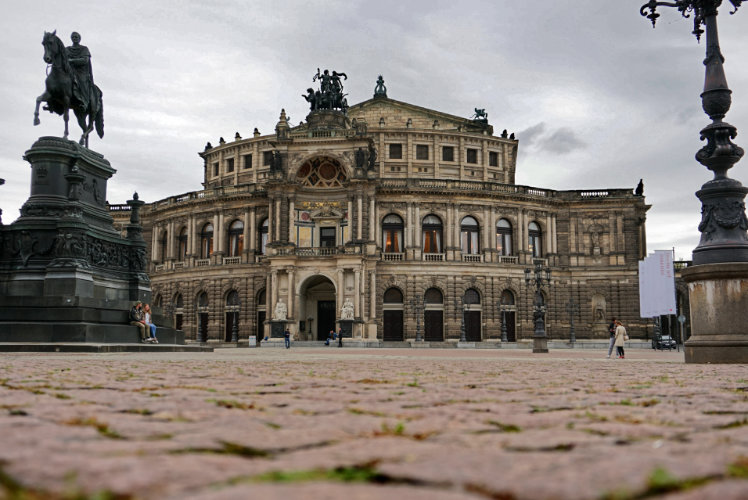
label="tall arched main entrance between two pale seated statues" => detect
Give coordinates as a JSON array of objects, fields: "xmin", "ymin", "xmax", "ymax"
[{"xmin": 298, "ymin": 275, "xmax": 336, "ymax": 340}]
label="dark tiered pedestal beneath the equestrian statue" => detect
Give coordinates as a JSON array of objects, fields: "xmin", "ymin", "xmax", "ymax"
[{"xmin": 0, "ymin": 137, "xmax": 166, "ymax": 342}]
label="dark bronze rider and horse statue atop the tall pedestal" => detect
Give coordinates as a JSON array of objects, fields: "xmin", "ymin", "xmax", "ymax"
[{"xmin": 34, "ymin": 31, "xmax": 104, "ymax": 147}]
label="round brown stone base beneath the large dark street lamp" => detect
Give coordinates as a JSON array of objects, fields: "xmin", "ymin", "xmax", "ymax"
[{"xmin": 681, "ymin": 262, "xmax": 748, "ymax": 363}]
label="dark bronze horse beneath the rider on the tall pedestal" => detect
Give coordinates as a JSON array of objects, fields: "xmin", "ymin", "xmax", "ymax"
[{"xmin": 34, "ymin": 30, "xmax": 104, "ymax": 147}]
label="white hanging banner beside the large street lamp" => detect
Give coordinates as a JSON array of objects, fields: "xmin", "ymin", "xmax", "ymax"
[{"xmin": 639, "ymin": 250, "xmax": 676, "ymax": 318}]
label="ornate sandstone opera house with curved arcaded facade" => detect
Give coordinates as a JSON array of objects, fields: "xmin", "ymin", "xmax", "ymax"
[{"xmin": 111, "ymin": 80, "xmax": 649, "ymax": 342}]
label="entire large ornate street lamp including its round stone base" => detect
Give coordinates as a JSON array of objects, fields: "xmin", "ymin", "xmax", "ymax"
[{"xmin": 640, "ymin": 0, "xmax": 748, "ymax": 363}]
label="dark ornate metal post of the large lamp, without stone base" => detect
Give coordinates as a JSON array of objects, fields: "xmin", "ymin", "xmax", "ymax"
[{"xmin": 640, "ymin": 0, "xmax": 748, "ymax": 265}]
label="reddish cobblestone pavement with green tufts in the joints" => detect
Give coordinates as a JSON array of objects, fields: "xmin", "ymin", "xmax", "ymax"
[{"xmin": 0, "ymin": 348, "xmax": 748, "ymax": 500}]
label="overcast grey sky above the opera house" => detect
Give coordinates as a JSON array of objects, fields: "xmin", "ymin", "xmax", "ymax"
[{"xmin": 0, "ymin": 0, "xmax": 748, "ymax": 259}]
